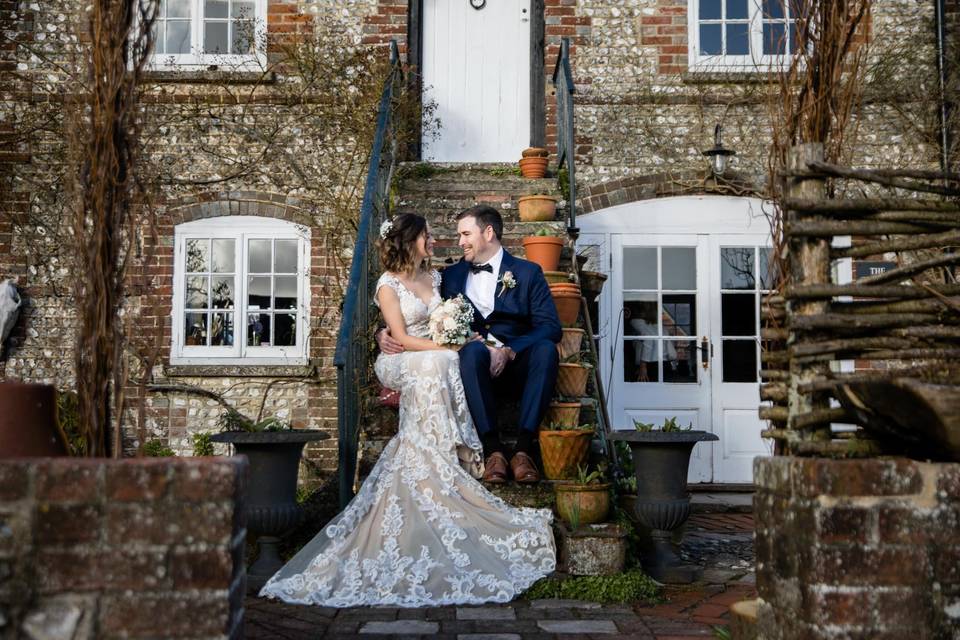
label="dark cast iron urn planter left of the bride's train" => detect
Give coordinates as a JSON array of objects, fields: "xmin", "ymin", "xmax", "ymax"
[{"xmin": 210, "ymin": 431, "xmax": 330, "ymax": 591}]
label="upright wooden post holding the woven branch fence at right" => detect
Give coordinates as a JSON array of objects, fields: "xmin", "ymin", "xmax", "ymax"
[{"xmin": 784, "ymin": 143, "xmax": 830, "ymax": 454}]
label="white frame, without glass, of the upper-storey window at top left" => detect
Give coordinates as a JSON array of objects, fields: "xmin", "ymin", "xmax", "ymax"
[{"xmin": 148, "ymin": 0, "xmax": 267, "ymax": 71}]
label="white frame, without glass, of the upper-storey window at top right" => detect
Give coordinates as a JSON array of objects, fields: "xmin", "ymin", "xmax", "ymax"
[{"xmin": 687, "ymin": 0, "xmax": 792, "ymax": 72}]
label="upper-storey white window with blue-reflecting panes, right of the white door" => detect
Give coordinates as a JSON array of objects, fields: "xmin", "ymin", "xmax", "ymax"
[{"xmin": 689, "ymin": 0, "xmax": 802, "ymax": 69}]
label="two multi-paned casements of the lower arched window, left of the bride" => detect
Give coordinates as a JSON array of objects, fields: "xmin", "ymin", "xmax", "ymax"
[{"xmin": 172, "ymin": 218, "xmax": 309, "ymax": 362}]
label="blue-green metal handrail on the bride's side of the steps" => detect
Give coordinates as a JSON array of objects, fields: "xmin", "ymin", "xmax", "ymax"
[{"xmin": 333, "ymin": 41, "xmax": 403, "ymax": 508}]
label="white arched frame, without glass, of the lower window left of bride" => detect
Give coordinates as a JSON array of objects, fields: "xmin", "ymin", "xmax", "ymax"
[{"xmin": 170, "ymin": 216, "xmax": 310, "ymax": 365}]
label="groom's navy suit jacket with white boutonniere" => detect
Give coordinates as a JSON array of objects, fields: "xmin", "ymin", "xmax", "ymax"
[{"xmin": 440, "ymin": 250, "xmax": 563, "ymax": 353}]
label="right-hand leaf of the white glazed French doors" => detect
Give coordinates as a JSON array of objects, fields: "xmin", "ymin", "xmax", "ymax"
[{"xmin": 710, "ymin": 235, "xmax": 775, "ymax": 482}]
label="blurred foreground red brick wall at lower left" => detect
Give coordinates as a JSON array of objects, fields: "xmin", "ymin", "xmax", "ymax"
[{"xmin": 0, "ymin": 458, "xmax": 247, "ymax": 638}]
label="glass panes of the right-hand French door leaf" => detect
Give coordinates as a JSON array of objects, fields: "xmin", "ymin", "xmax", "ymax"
[{"xmin": 720, "ymin": 246, "xmax": 776, "ymax": 382}]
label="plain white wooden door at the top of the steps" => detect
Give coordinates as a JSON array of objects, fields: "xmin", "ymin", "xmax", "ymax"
[{"xmin": 421, "ymin": 0, "xmax": 530, "ymax": 162}]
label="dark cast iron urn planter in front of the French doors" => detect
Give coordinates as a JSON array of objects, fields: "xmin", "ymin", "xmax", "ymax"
[{"xmin": 610, "ymin": 431, "xmax": 719, "ymax": 584}]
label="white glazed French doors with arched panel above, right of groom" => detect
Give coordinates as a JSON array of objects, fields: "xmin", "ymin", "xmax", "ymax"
[{"xmin": 577, "ymin": 196, "xmax": 770, "ymax": 483}]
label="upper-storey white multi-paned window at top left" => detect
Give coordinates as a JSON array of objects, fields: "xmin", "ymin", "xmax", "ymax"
[{"xmin": 154, "ymin": 0, "xmax": 266, "ymax": 64}]
